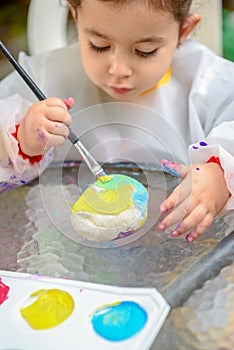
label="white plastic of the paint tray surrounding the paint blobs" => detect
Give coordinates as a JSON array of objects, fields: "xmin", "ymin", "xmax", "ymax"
[{"xmin": 0, "ymin": 270, "xmax": 170, "ymax": 350}]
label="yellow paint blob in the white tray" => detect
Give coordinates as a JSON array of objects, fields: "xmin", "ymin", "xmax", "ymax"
[{"xmin": 20, "ymin": 289, "xmax": 74, "ymax": 330}]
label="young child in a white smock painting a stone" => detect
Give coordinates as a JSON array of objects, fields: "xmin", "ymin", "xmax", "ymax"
[{"xmin": 0, "ymin": 0, "xmax": 234, "ymax": 242}]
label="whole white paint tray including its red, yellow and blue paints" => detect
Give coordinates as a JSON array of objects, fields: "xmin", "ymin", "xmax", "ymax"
[{"xmin": 0, "ymin": 271, "xmax": 170, "ymax": 350}]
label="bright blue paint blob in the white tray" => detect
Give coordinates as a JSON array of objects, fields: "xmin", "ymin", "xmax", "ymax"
[{"xmin": 91, "ymin": 301, "xmax": 147, "ymax": 341}]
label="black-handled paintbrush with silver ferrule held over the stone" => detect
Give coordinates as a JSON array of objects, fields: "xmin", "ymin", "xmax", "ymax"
[{"xmin": 0, "ymin": 40, "xmax": 106, "ymax": 177}]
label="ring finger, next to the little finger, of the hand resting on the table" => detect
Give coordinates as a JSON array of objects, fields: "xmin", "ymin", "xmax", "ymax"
[{"xmin": 168, "ymin": 204, "xmax": 208, "ymax": 237}]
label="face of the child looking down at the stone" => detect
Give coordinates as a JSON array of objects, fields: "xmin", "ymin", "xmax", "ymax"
[{"xmin": 77, "ymin": 0, "xmax": 179, "ymax": 101}]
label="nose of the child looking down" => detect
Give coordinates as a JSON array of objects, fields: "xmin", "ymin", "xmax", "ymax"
[{"xmin": 109, "ymin": 55, "xmax": 132, "ymax": 77}]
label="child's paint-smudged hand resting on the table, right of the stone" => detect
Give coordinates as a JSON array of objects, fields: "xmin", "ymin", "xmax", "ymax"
[{"xmin": 158, "ymin": 163, "xmax": 230, "ymax": 242}]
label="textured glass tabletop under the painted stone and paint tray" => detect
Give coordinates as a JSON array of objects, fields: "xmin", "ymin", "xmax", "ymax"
[{"xmin": 0, "ymin": 164, "xmax": 234, "ymax": 350}]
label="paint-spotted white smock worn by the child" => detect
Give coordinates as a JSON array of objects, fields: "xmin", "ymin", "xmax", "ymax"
[{"xmin": 0, "ymin": 39, "xmax": 234, "ymax": 209}]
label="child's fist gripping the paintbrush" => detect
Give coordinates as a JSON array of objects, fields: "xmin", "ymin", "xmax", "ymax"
[{"xmin": 17, "ymin": 97, "xmax": 74, "ymax": 157}]
